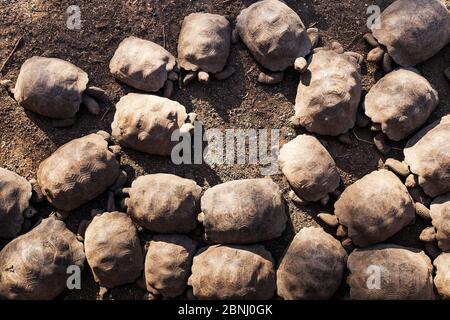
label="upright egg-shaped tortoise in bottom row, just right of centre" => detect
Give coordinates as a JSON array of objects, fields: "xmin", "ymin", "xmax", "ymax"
[{"xmin": 277, "ymin": 227, "xmax": 347, "ymax": 300}]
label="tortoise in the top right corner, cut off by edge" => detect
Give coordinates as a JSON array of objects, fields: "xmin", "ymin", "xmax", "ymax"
[{"xmin": 365, "ymin": 0, "xmax": 450, "ymax": 72}]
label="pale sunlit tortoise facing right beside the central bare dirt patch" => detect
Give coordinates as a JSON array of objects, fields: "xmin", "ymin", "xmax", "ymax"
[{"xmin": 111, "ymin": 93, "xmax": 196, "ymax": 156}]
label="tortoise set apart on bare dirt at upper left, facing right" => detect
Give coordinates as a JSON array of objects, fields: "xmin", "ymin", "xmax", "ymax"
[{"xmin": 13, "ymin": 56, "xmax": 107, "ymax": 127}]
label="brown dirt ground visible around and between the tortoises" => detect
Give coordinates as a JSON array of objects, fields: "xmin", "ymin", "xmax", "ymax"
[{"xmin": 0, "ymin": 0, "xmax": 450, "ymax": 299}]
